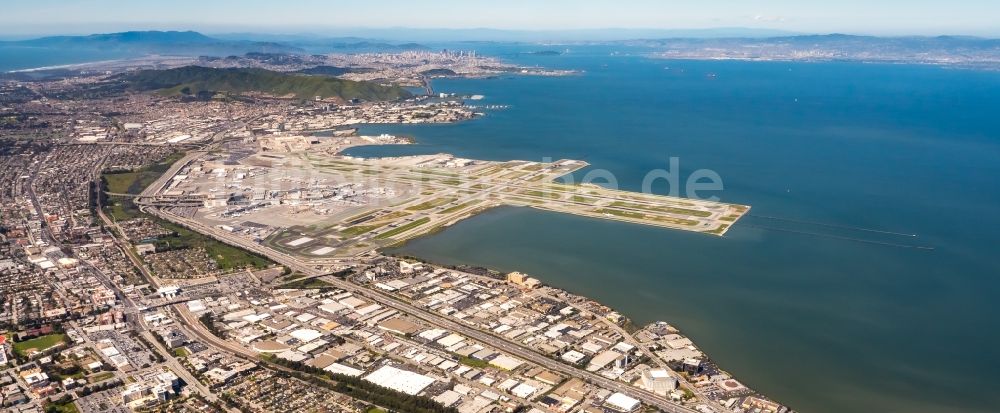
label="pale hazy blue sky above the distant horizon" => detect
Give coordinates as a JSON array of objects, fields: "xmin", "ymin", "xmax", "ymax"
[{"xmin": 0, "ymin": 0, "xmax": 1000, "ymax": 36}]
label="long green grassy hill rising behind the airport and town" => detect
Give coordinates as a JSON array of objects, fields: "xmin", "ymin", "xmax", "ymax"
[{"xmin": 122, "ymin": 66, "xmax": 412, "ymax": 101}]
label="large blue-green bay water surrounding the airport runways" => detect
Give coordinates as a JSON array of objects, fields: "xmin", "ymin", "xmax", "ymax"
[{"xmin": 352, "ymin": 49, "xmax": 1000, "ymax": 412}]
